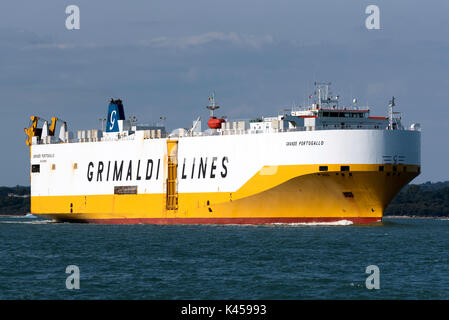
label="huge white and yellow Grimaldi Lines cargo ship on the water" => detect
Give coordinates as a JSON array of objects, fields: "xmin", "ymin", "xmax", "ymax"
[{"xmin": 25, "ymin": 83, "xmax": 421, "ymax": 224}]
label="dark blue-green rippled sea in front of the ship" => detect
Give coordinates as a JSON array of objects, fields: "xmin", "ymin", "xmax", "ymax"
[{"xmin": 0, "ymin": 217, "xmax": 449, "ymax": 299}]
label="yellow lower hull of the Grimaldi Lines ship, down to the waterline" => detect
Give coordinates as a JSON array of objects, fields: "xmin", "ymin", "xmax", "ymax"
[{"xmin": 31, "ymin": 164, "xmax": 420, "ymax": 224}]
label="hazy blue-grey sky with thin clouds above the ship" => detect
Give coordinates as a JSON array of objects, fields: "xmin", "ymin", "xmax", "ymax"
[{"xmin": 0, "ymin": 0, "xmax": 449, "ymax": 186}]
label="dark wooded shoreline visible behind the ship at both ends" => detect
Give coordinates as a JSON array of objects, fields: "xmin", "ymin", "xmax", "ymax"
[{"xmin": 0, "ymin": 181, "xmax": 449, "ymax": 217}]
